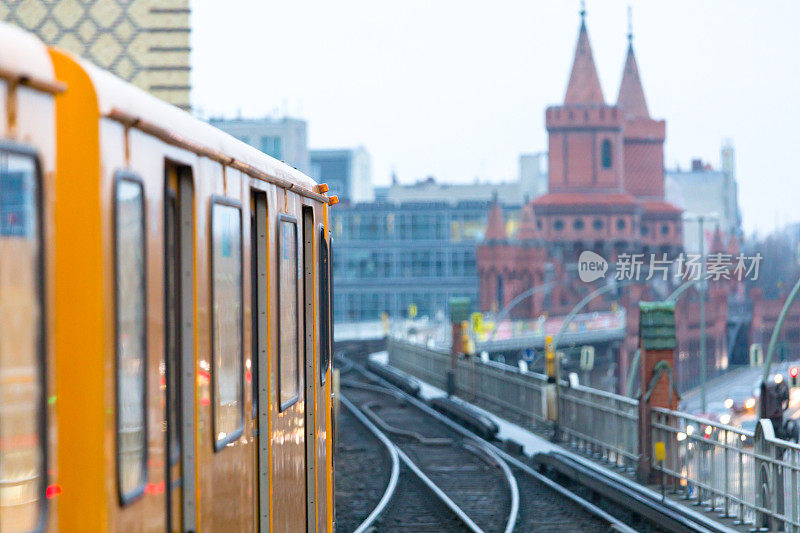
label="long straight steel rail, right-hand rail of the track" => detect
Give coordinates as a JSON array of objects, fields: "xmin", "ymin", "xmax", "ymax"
[{"xmin": 353, "ymin": 363, "xmax": 636, "ymax": 533}]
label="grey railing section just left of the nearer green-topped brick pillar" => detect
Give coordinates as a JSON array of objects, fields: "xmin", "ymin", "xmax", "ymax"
[{"xmin": 558, "ymin": 386, "xmax": 639, "ymax": 470}]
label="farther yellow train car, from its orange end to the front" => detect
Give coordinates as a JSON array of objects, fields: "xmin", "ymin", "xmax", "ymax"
[{"xmin": 45, "ymin": 32, "xmax": 333, "ymax": 531}]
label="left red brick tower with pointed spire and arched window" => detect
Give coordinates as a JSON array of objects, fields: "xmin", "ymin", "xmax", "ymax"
[{"xmin": 533, "ymin": 12, "xmax": 640, "ymax": 262}]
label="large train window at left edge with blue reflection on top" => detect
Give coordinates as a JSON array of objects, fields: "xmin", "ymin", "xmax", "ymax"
[{"xmin": 0, "ymin": 150, "xmax": 46, "ymax": 531}]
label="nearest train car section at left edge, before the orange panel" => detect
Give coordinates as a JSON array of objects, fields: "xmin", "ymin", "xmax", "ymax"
[{"xmin": 0, "ymin": 24, "xmax": 58, "ymax": 530}]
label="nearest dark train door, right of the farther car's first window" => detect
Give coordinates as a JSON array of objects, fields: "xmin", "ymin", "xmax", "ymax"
[{"xmin": 163, "ymin": 163, "xmax": 197, "ymax": 532}]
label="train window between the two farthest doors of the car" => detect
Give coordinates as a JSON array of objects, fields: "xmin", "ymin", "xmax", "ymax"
[{"xmin": 278, "ymin": 214, "xmax": 300, "ymax": 410}]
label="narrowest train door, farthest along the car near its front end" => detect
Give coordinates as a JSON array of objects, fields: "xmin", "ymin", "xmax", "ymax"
[{"xmin": 303, "ymin": 206, "xmax": 317, "ymax": 531}]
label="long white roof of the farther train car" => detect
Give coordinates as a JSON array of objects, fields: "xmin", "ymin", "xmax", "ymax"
[{"xmin": 71, "ymin": 52, "xmax": 317, "ymax": 193}]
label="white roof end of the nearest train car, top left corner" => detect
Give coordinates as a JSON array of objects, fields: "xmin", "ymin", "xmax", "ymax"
[{"xmin": 0, "ymin": 22, "xmax": 56, "ymax": 85}]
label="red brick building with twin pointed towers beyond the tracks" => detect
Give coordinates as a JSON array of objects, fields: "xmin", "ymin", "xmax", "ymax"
[{"xmin": 477, "ymin": 14, "xmax": 683, "ymax": 386}]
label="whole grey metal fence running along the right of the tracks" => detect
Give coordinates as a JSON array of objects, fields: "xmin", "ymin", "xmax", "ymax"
[{"xmin": 388, "ymin": 339, "xmax": 800, "ymax": 533}]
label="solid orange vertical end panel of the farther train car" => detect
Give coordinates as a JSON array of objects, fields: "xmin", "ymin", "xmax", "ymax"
[{"xmin": 51, "ymin": 47, "xmax": 111, "ymax": 531}]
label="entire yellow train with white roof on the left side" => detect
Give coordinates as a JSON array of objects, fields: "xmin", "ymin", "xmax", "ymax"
[{"xmin": 0, "ymin": 19, "xmax": 335, "ymax": 532}]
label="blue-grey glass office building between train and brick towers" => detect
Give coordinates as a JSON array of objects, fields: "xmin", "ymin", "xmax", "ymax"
[{"xmin": 330, "ymin": 200, "xmax": 519, "ymax": 322}]
